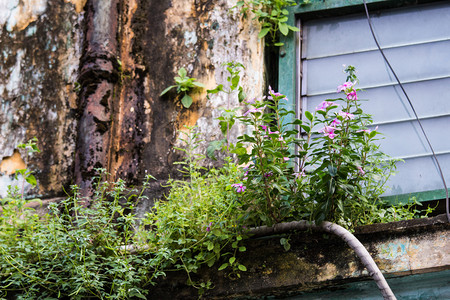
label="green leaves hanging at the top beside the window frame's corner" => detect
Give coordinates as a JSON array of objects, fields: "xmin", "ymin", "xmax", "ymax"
[{"xmin": 235, "ymin": 0, "xmax": 309, "ymax": 46}]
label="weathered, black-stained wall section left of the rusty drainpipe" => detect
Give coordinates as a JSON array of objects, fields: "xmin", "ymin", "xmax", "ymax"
[{"xmin": 0, "ymin": 0, "xmax": 84, "ymax": 197}]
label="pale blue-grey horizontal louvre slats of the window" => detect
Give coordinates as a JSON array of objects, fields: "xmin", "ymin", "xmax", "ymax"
[{"xmin": 301, "ymin": 3, "xmax": 450, "ymax": 196}]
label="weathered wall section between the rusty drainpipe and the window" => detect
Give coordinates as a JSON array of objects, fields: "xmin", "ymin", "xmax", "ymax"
[{"xmin": 122, "ymin": 0, "xmax": 263, "ymax": 183}]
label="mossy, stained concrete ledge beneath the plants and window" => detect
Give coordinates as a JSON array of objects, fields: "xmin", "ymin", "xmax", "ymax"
[{"xmin": 149, "ymin": 215, "xmax": 450, "ymax": 299}]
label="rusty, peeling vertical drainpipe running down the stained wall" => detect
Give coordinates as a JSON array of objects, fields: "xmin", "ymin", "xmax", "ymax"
[{"xmin": 74, "ymin": 0, "xmax": 119, "ymax": 205}]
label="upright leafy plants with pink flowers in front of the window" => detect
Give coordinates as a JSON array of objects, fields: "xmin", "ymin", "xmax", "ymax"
[{"xmin": 232, "ymin": 67, "xmax": 424, "ymax": 228}]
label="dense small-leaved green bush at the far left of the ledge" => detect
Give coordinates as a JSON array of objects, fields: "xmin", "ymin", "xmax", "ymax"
[{"xmin": 0, "ymin": 171, "xmax": 153, "ymax": 299}]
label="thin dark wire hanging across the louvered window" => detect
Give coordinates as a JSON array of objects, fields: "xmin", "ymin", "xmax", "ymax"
[{"xmin": 363, "ymin": 0, "xmax": 450, "ymax": 223}]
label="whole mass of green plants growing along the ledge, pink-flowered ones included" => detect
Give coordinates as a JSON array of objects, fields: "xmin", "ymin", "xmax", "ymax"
[{"xmin": 0, "ymin": 67, "xmax": 430, "ymax": 299}]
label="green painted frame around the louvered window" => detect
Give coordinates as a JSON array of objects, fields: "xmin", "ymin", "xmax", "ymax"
[{"xmin": 278, "ymin": 0, "xmax": 448, "ymax": 203}]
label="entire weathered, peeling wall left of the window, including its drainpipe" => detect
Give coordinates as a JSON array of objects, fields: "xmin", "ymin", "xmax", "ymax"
[{"xmin": 0, "ymin": 0, "xmax": 264, "ymax": 197}]
